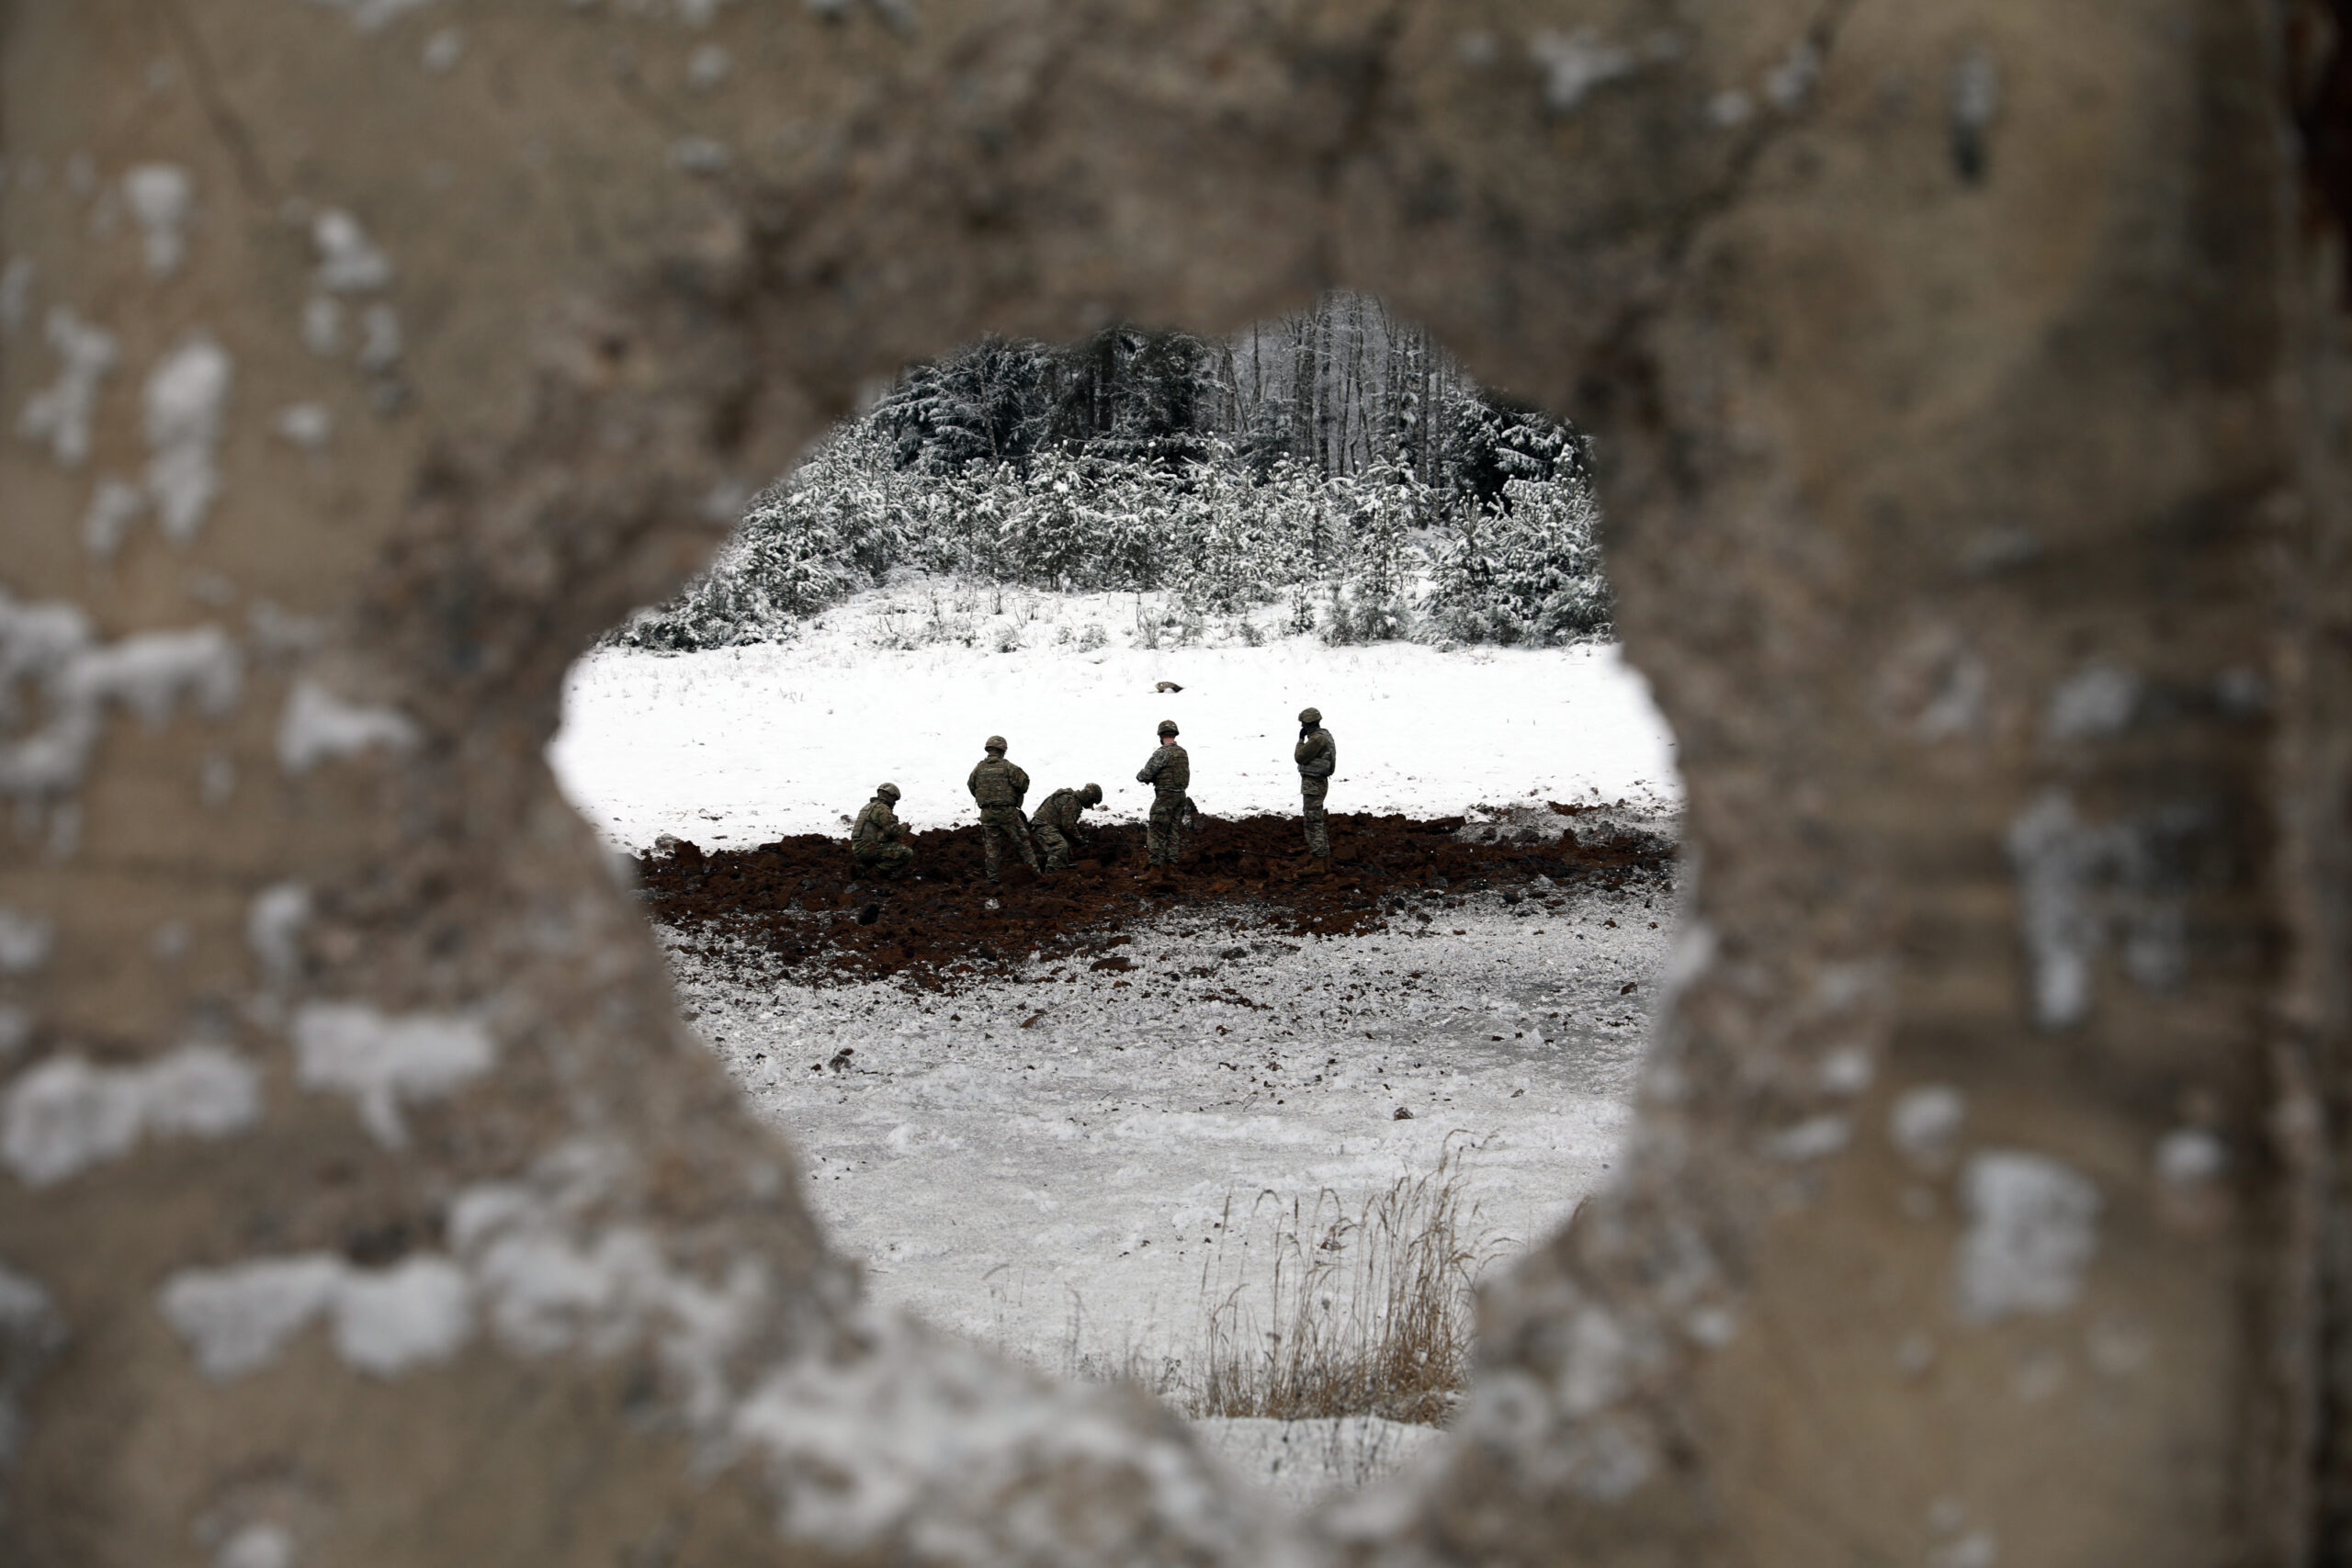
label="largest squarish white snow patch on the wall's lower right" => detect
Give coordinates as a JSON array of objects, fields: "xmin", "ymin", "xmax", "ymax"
[{"xmin": 1957, "ymin": 1149, "xmax": 2098, "ymax": 1324}]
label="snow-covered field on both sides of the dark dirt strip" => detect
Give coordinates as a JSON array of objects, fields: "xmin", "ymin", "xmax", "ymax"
[{"xmin": 550, "ymin": 600, "xmax": 1679, "ymax": 1502}]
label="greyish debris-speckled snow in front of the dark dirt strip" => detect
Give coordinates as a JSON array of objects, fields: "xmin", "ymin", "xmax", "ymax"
[{"xmin": 673, "ymin": 886, "xmax": 1672, "ymax": 1495}]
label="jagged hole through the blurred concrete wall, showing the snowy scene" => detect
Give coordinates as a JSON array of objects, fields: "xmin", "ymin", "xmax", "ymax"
[{"xmin": 550, "ymin": 294, "xmax": 1679, "ymax": 1500}]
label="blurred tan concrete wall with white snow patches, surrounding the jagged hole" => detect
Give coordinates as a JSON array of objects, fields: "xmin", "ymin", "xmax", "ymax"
[{"xmin": 0, "ymin": 0, "xmax": 2352, "ymax": 1568}]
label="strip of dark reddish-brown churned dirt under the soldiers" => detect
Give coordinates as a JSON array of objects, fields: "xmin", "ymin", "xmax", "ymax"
[{"xmin": 638, "ymin": 807, "xmax": 1675, "ymax": 989}]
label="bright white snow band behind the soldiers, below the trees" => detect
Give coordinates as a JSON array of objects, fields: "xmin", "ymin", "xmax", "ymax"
[{"xmin": 548, "ymin": 590, "xmax": 1679, "ymax": 849}]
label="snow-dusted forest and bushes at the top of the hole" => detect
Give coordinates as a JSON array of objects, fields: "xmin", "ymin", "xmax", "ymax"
[{"xmin": 612, "ymin": 294, "xmax": 1609, "ymax": 651}]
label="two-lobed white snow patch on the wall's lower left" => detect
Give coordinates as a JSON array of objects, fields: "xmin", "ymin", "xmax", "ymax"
[{"xmin": 158, "ymin": 1253, "xmax": 473, "ymax": 1382}]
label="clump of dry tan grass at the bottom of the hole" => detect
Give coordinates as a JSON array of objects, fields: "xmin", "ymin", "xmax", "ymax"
[{"xmin": 1171, "ymin": 1147, "xmax": 1503, "ymax": 1427}]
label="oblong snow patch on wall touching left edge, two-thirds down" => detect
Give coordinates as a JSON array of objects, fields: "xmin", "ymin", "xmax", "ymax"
[{"xmin": 0, "ymin": 1046, "xmax": 261, "ymax": 1187}]
